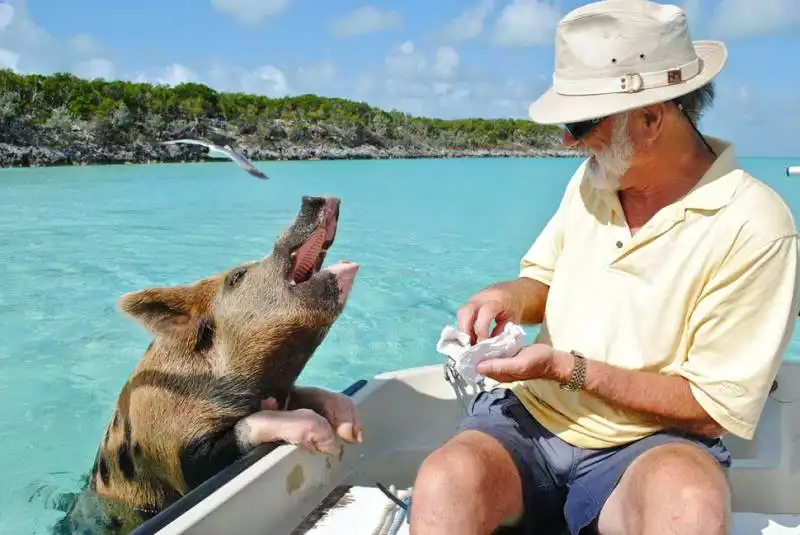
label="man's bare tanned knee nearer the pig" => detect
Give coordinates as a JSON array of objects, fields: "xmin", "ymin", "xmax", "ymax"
[{"xmin": 411, "ymin": 430, "xmax": 523, "ymax": 529}]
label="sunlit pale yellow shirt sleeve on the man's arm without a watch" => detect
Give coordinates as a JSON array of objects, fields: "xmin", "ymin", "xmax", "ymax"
[{"xmin": 519, "ymin": 169, "xmax": 584, "ymax": 286}]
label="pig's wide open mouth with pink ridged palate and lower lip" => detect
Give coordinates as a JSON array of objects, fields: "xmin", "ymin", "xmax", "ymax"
[{"xmin": 289, "ymin": 199, "xmax": 358, "ymax": 303}]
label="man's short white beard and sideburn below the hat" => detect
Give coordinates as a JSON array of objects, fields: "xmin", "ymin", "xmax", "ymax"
[{"xmin": 582, "ymin": 113, "xmax": 634, "ymax": 191}]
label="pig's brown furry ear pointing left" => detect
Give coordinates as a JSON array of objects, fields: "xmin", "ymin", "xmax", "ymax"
[{"xmin": 119, "ymin": 287, "xmax": 192, "ymax": 334}]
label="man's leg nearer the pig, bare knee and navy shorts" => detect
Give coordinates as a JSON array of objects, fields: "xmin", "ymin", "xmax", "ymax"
[{"xmin": 409, "ymin": 389, "xmax": 566, "ymax": 535}]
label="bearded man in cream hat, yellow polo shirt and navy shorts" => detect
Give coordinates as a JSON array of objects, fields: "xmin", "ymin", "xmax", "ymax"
[{"xmin": 410, "ymin": 0, "xmax": 800, "ymax": 535}]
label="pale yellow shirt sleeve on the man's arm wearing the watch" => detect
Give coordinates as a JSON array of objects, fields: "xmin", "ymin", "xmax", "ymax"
[{"xmin": 680, "ymin": 234, "xmax": 800, "ymax": 440}]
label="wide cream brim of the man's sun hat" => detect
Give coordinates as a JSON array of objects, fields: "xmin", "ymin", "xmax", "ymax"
[{"xmin": 528, "ymin": 41, "xmax": 728, "ymax": 124}]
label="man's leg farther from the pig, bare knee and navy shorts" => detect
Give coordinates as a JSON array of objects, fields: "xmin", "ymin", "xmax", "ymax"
[{"xmin": 565, "ymin": 432, "xmax": 731, "ymax": 535}]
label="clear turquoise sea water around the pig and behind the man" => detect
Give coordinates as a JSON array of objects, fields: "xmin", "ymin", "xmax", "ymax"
[{"xmin": 0, "ymin": 159, "xmax": 800, "ymax": 535}]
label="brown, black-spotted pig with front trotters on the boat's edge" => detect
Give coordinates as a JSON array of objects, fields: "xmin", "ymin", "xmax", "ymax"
[{"xmin": 55, "ymin": 196, "xmax": 363, "ymax": 534}]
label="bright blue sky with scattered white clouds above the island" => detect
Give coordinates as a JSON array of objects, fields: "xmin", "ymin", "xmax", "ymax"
[{"xmin": 0, "ymin": 0, "xmax": 800, "ymax": 156}]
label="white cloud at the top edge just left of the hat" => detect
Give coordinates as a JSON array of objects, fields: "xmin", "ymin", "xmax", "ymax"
[{"xmin": 492, "ymin": 0, "xmax": 562, "ymax": 46}]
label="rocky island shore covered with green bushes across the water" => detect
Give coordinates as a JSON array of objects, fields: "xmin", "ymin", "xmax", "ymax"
[{"xmin": 0, "ymin": 70, "xmax": 576, "ymax": 167}]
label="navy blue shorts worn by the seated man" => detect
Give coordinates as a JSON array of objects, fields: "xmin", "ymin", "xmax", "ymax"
[{"xmin": 460, "ymin": 388, "xmax": 731, "ymax": 535}]
